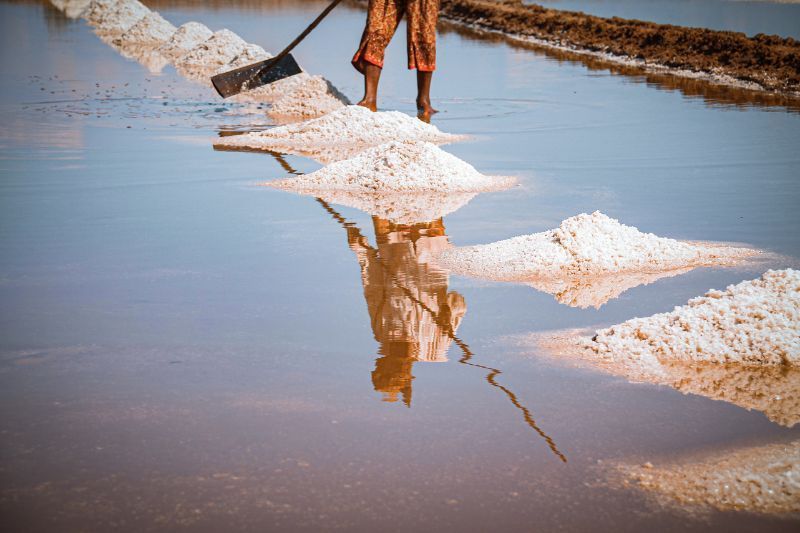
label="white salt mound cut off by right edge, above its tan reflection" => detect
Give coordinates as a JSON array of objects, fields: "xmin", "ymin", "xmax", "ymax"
[{"xmin": 582, "ymin": 269, "xmax": 800, "ymax": 364}]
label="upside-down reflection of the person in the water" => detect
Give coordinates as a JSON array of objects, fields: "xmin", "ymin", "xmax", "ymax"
[{"xmin": 347, "ymin": 217, "xmax": 467, "ymax": 405}]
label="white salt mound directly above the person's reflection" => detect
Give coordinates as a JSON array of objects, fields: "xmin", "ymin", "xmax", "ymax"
[{"xmin": 265, "ymin": 141, "xmax": 516, "ymax": 193}]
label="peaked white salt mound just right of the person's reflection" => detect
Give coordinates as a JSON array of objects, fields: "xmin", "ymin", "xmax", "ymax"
[{"xmin": 440, "ymin": 211, "xmax": 755, "ymax": 281}]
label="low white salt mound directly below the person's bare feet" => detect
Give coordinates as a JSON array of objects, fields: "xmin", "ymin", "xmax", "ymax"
[{"xmin": 217, "ymin": 106, "xmax": 464, "ymax": 163}]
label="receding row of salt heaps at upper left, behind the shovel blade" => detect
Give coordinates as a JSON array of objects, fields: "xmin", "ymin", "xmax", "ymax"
[{"xmin": 52, "ymin": 0, "xmax": 350, "ymax": 123}]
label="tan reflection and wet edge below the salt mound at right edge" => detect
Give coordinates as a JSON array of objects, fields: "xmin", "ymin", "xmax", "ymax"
[{"xmin": 523, "ymin": 330, "xmax": 800, "ymax": 427}]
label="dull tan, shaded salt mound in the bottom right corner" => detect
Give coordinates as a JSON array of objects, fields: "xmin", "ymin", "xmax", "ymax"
[{"xmin": 617, "ymin": 440, "xmax": 800, "ymax": 515}]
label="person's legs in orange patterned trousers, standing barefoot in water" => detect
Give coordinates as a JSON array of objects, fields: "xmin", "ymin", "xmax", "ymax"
[{"xmin": 353, "ymin": 0, "xmax": 439, "ymax": 120}]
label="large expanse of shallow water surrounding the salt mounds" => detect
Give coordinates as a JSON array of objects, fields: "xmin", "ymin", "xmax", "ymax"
[{"xmin": 0, "ymin": 2, "xmax": 800, "ymax": 531}]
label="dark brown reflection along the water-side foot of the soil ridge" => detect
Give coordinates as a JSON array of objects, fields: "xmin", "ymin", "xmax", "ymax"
[{"xmin": 439, "ymin": 21, "xmax": 800, "ymax": 113}]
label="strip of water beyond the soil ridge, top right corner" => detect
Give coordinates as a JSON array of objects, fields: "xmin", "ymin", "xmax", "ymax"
[{"xmin": 526, "ymin": 0, "xmax": 800, "ymax": 39}]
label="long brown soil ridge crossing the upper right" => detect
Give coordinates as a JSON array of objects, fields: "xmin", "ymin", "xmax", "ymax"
[{"xmin": 441, "ymin": 0, "xmax": 800, "ymax": 93}]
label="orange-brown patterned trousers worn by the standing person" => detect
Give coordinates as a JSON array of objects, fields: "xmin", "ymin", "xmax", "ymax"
[{"xmin": 353, "ymin": 0, "xmax": 439, "ymax": 73}]
